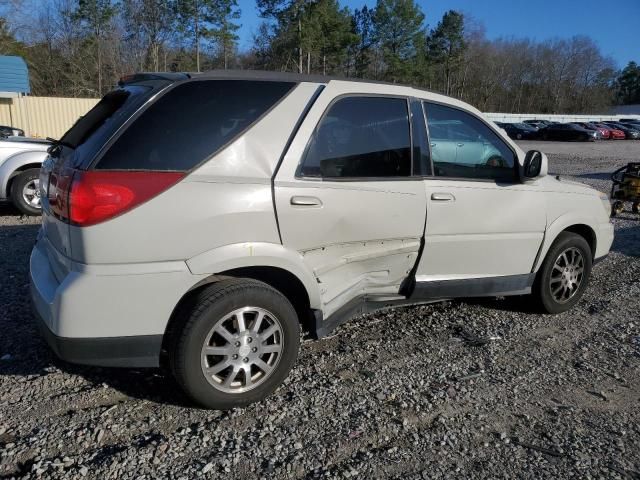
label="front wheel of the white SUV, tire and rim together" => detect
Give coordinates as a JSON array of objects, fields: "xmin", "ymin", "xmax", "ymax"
[{"xmin": 533, "ymin": 232, "xmax": 592, "ymax": 313}]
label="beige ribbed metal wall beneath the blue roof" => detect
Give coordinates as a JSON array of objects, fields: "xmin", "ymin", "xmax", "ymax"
[{"xmin": 0, "ymin": 97, "xmax": 98, "ymax": 138}]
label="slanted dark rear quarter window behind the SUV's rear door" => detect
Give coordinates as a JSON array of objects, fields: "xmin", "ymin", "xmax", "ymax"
[{"xmin": 95, "ymin": 80, "xmax": 295, "ymax": 171}]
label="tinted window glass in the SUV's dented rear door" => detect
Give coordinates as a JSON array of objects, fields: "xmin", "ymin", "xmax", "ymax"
[{"xmin": 299, "ymin": 97, "xmax": 411, "ymax": 178}]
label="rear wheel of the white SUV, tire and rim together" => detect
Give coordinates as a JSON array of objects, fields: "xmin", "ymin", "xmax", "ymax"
[{"xmin": 170, "ymin": 279, "xmax": 300, "ymax": 410}]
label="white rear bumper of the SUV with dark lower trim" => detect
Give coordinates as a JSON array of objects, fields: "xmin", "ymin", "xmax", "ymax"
[{"xmin": 29, "ymin": 237, "xmax": 200, "ymax": 367}]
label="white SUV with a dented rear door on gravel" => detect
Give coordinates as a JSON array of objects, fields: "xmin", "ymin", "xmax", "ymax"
[{"xmin": 31, "ymin": 72, "xmax": 613, "ymax": 408}]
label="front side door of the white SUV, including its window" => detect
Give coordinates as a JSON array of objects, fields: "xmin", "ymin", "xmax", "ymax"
[{"xmin": 416, "ymin": 103, "xmax": 546, "ymax": 296}]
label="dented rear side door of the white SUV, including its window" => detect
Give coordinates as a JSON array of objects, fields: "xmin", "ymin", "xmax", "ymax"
[{"xmin": 275, "ymin": 81, "xmax": 426, "ymax": 317}]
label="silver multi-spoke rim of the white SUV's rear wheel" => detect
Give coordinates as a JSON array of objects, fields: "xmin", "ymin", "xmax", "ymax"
[{"xmin": 201, "ymin": 307, "xmax": 284, "ymax": 393}]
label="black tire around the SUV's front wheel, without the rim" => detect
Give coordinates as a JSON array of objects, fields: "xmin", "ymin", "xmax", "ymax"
[{"xmin": 532, "ymin": 232, "xmax": 593, "ymax": 313}]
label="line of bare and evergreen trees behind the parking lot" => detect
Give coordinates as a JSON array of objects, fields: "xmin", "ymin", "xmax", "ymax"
[{"xmin": 0, "ymin": 0, "xmax": 640, "ymax": 113}]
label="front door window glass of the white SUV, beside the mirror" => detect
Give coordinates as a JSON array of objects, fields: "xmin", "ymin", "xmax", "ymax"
[{"xmin": 425, "ymin": 103, "xmax": 515, "ymax": 182}]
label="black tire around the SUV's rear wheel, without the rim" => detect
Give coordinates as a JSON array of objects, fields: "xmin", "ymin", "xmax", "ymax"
[{"xmin": 169, "ymin": 279, "xmax": 300, "ymax": 410}]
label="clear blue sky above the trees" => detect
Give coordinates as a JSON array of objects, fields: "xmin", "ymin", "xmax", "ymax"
[{"xmin": 238, "ymin": 0, "xmax": 640, "ymax": 68}]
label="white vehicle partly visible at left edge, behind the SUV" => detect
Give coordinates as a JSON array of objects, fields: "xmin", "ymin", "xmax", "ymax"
[{"xmin": 0, "ymin": 137, "xmax": 51, "ymax": 215}]
